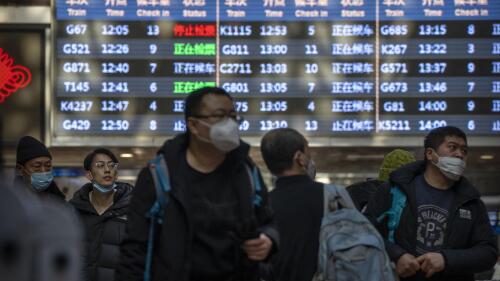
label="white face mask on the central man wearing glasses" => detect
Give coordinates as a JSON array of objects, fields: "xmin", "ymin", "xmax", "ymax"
[{"xmin": 199, "ymin": 118, "xmax": 240, "ymax": 152}]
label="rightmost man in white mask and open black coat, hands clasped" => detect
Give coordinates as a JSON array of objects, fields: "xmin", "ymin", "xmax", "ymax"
[{"xmin": 367, "ymin": 126, "xmax": 498, "ymax": 281}]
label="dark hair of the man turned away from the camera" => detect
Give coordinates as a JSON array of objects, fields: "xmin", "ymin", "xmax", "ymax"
[{"xmin": 260, "ymin": 128, "xmax": 307, "ymax": 175}]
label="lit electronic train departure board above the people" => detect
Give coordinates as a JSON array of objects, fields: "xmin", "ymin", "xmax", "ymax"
[{"xmin": 51, "ymin": 0, "xmax": 500, "ymax": 143}]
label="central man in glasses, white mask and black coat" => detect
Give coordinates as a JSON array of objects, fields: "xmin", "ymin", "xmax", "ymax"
[{"xmin": 115, "ymin": 88, "xmax": 278, "ymax": 281}]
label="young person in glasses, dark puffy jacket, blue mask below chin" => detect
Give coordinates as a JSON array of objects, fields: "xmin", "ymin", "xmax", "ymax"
[{"xmin": 70, "ymin": 148, "xmax": 132, "ymax": 281}]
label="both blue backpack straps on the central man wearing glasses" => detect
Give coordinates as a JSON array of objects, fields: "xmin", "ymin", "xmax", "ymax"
[{"xmin": 144, "ymin": 154, "xmax": 262, "ymax": 281}]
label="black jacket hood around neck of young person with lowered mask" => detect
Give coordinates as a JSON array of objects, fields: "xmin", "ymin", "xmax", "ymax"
[{"xmin": 69, "ymin": 181, "xmax": 133, "ymax": 213}]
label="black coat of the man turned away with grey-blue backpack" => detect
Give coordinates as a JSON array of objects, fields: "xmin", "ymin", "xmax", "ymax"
[{"xmin": 269, "ymin": 175, "xmax": 324, "ymax": 281}]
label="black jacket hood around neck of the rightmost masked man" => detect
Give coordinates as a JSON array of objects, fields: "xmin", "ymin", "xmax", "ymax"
[{"xmin": 389, "ymin": 161, "xmax": 481, "ymax": 200}]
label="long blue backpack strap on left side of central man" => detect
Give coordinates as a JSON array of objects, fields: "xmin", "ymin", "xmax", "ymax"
[{"xmin": 144, "ymin": 154, "xmax": 171, "ymax": 281}]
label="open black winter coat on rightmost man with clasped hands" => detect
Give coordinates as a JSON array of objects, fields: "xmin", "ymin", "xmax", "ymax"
[{"xmin": 367, "ymin": 161, "xmax": 498, "ymax": 281}]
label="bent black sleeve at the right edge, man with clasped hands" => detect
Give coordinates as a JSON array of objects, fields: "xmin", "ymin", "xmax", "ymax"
[{"xmin": 441, "ymin": 199, "xmax": 498, "ymax": 274}]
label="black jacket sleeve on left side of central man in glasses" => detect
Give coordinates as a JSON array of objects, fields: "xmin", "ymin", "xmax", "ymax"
[{"xmin": 115, "ymin": 168, "xmax": 156, "ymax": 281}]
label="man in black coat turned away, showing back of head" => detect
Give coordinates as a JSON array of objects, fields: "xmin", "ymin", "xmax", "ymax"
[{"xmin": 260, "ymin": 128, "xmax": 323, "ymax": 281}]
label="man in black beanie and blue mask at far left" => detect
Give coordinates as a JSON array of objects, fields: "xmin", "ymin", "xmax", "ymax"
[{"xmin": 16, "ymin": 136, "xmax": 65, "ymax": 200}]
